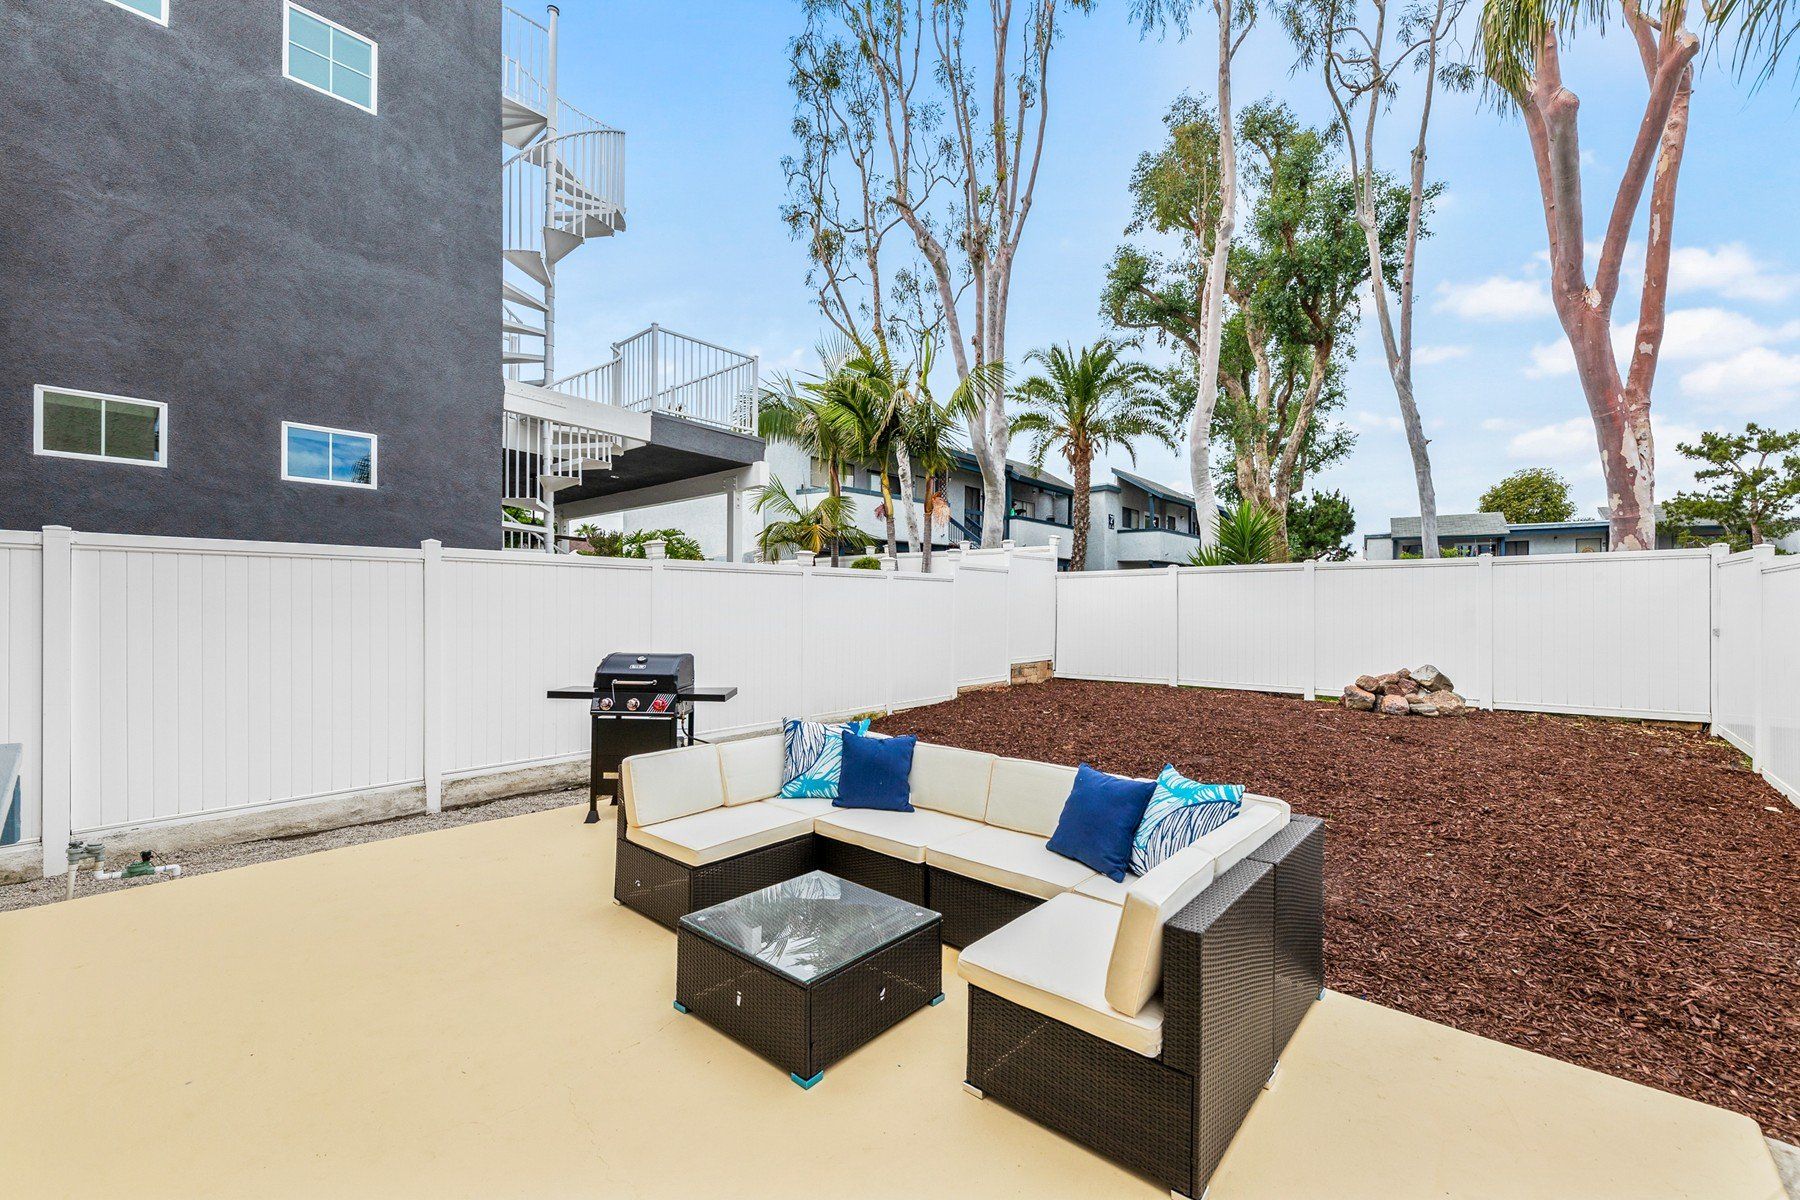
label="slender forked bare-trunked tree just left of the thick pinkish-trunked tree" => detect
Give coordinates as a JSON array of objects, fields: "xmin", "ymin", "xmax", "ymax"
[{"xmin": 1280, "ymin": 0, "xmax": 1469, "ymax": 558}]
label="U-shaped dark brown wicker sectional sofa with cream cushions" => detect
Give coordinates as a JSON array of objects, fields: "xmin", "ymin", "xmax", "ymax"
[{"xmin": 614, "ymin": 734, "xmax": 1325, "ymax": 1196}]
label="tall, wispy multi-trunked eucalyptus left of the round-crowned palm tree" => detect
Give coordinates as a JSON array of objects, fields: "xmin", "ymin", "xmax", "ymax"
[{"xmin": 788, "ymin": 0, "xmax": 1091, "ymax": 545}]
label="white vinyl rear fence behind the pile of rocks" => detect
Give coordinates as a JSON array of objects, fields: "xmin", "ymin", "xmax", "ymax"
[{"xmin": 1057, "ymin": 551, "xmax": 1714, "ymax": 721}]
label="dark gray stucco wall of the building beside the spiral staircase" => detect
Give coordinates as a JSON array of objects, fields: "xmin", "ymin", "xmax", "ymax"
[{"xmin": 0, "ymin": 0, "xmax": 500, "ymax": 547}]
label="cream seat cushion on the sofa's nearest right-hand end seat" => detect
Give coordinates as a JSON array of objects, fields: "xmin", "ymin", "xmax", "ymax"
[{"xmin": 956, "ymin": 892, "xmax": 1163, "ymax": 1058}]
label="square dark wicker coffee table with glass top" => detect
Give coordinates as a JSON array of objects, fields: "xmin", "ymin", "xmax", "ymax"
[{"xmin": 675, "ymin": 871, "xmax": 943, "ymax": 1088}]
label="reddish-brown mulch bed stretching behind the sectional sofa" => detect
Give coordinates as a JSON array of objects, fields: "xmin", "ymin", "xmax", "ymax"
[{"xmin": 878, "ymin": 680, "xmax": 1800, "ymax": 1141}]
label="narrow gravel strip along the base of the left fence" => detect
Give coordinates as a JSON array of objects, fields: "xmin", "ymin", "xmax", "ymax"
[{"xmin": 0, "ymin": 786, "xmax": 583, "ymax": 912}]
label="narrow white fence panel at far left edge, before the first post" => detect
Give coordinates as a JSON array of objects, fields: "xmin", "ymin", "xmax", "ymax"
[{"xmin": 0, "ymin": 533, "xmax": 43, "ymax": 846}]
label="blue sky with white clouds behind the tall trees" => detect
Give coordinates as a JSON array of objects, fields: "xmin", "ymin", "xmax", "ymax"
[{"xmin": 558, "ymin": 0, "xmax": 1800, "ymax": 543}]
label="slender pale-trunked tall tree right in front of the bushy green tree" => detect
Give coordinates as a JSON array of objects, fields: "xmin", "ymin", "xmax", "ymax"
[{"xmin": 1132, "ymin": 0, "xmax": 1256, "ymax": 547}]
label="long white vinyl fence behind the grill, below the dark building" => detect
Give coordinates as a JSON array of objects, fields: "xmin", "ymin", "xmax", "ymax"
[{"xmin": 0, "ymin": 529, "xmax": 1055, "ymax": 873}]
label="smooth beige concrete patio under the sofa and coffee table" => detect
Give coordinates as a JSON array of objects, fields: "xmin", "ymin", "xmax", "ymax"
[{"xmin": 0, "ymin": 810, "xmax": 1784, "ymax": 1200}]
